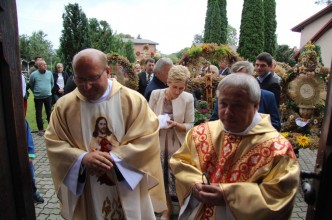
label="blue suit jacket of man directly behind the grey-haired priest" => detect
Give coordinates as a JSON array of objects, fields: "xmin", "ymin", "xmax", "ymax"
[{"xmin": 210, "ymin": 89, "xmax": 281, "ymax": 131}]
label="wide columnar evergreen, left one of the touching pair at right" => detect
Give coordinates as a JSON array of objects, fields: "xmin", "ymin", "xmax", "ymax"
[{"xmin": 237, "ymin": 0, "xmax": 264, "ymax": 62}]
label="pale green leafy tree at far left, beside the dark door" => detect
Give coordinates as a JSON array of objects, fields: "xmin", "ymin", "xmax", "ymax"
[{"xmin": 19, "ymin": 30, "xmax": 55, "ymax": 62}]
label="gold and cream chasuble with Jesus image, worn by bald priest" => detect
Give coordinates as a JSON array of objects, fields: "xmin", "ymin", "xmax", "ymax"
[{"xmin": 45, "ymin": 80, "xmax": 167, "ymax": 220}]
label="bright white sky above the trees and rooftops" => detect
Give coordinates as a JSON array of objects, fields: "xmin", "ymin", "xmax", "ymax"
[{"xmin": 16, "ymin": 0, "xmax": 325, "ymax": 54}]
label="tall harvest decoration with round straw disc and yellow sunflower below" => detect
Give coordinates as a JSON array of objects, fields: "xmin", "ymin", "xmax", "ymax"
[{"xmin": 279, "ymin": 42, "xmax": 329, "ymax": 151}]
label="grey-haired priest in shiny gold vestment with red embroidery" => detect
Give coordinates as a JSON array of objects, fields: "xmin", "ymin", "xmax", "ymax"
[{"xmin": 170, "ymin": 73, "xmax": 300, "ymax": 220}]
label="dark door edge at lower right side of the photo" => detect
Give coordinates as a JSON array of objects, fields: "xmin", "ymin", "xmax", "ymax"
[{"xmin": 306, "ymin": 61, "xmax": 332, "ymax": 220}]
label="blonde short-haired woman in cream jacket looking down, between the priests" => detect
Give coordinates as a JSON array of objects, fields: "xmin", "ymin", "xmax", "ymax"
[{"xmin": 149, "ymin": 65, "xmax": 195, "ymax": 220}]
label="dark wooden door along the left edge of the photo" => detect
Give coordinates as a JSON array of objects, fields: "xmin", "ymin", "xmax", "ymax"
[{"xmin": 0, "ymin": 0, "xmax": 36, "ymax": 220}]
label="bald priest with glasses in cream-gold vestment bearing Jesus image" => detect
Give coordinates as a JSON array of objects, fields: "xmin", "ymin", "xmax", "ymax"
[{"xmin": 45, "ymin": 49, "xmax": 167, "ymax": 220}]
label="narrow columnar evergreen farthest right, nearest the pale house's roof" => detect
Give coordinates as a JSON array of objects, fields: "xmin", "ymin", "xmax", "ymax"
[{"xmin": 263, "ymin": 0, "xmax": 278, "ymax": 56}]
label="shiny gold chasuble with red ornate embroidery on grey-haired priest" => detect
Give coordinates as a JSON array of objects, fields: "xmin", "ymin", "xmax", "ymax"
[{"xmin": 170, "ymin": 114, "xmax": 299, "ymax": 219}]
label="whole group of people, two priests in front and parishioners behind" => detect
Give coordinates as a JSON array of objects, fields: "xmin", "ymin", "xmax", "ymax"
[{"xmin": 24, "ymin": 49, "xmax": 299, "ymax": 220}]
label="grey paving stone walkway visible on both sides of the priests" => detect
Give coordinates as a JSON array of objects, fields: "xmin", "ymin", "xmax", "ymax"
[{"xmin": 33, "ymin": 133, "xmax": 317, "ymax": 220}]
